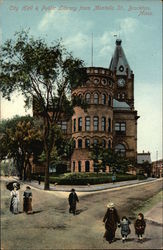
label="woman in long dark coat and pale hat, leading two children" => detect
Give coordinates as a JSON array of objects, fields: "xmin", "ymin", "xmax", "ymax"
[{"xmin": 103, "ymin": 202, "xmax": 120, "ymax": 243}]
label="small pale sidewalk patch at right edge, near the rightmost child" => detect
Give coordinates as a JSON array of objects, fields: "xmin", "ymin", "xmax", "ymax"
[{"xmin": 145, "ymin": 202, "xmax": 163, "ymax": 226}]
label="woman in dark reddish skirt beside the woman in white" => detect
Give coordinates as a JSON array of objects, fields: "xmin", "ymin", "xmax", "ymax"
[{"xmin": 23, "ymin": 186, "xmax": 32, "ymax": 214}]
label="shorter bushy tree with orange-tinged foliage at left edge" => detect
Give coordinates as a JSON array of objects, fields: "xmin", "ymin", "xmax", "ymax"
[{"xmin": 0, "ymin": 116, "xmax": 42, "ymax": 179}]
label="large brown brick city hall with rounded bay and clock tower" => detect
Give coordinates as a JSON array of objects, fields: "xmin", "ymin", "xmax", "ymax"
[{"xmin": 58, "ymin": 39, "xmax": 139, "ymax": 172}]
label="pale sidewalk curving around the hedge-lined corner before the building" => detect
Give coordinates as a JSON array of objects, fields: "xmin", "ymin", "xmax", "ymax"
[{"xmin": 20, "ymin": 178, "xmax": 162, "ymax": 192}]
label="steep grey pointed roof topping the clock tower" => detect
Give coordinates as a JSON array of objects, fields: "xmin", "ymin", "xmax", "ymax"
[{"xmin": 109, "ymin": 39, "xmax": 131, "ymax": 78}]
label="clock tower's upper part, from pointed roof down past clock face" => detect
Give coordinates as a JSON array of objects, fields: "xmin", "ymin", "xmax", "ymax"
[{"xmin": 109, "ymin": 39, "xmax": 134, "ymax": 108}]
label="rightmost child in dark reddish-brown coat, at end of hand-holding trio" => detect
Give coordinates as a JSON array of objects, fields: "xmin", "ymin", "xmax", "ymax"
[{"xmin": 134, "ymin": 213, "xmax": 146, "ymax": 242}]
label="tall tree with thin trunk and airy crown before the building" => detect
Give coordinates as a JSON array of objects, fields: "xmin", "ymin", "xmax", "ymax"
[{"xmin": 0, "ymin": 31, "xmax": 87, "ymax": 189}]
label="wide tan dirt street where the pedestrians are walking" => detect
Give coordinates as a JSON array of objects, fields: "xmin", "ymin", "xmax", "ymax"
[{"xmin": 1, "ymin": 178, "xmax": 162, "ymax": 250}]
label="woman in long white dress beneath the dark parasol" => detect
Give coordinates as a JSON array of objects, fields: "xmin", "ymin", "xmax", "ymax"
[{"xmin": 10, "ymin": 183, "xmax": 19, "ymax": 214}]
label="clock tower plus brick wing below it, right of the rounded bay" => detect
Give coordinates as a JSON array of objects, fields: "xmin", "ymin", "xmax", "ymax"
[{"xmin": 109, "ymin": 39, "xmax": 139, "ymax": 160}]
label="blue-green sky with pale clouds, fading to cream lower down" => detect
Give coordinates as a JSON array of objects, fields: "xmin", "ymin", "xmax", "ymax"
[{"xmin": 0, "ymin": 0, "xmax": 162, "ymax": 161}]
